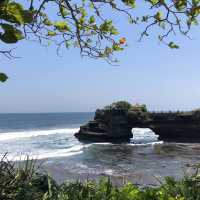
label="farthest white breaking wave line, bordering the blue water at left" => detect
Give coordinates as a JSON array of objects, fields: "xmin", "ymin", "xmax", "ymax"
[{"xmin": 0, "ymin": 128, "xmax": 79, "ymax": 141}]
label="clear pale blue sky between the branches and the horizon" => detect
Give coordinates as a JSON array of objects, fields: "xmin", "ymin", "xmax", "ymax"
[{"xmin": 0, "ymin": 5, "xmax": 200, "ymax": 113}]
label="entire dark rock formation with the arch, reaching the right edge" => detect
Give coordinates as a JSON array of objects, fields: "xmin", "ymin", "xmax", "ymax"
[{"xmin": 75, "ymin": 102, "xmax": 200, "ymax": 141}]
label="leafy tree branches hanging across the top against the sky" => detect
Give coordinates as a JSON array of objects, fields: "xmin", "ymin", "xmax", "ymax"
[{"xmin": 0, "ymin": 0, "xmax": 200, "ymax": 82}]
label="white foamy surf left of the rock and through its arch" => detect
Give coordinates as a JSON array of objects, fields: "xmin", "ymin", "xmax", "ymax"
[{"xmin": 0, "ymin": 128, "xmax": 162, "ymax": 162}]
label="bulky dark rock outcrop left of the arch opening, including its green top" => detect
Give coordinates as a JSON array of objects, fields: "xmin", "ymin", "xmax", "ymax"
[{"xmin": 75, "ymin": 102, "xmax": 146, "ymax": 141}]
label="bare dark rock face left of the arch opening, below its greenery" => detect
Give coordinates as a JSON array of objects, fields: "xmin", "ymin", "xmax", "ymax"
[{"xmin": 75, "ymin": 110, "xmax": 132, "ymax": 141}]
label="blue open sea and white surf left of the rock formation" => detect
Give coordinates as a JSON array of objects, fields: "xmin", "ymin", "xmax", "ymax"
[{"xmin": 0, "ymin": 113, "xmax": 94, "ymax": 160}]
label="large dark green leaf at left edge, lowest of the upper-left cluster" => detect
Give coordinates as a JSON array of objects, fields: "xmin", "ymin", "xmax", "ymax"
[{"xmin": 0, "ymin": 24, "xmax": 24, "ymax": 44}]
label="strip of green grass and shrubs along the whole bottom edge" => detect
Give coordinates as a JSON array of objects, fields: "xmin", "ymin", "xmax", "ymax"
[{"xmin": 0, "ymin": 159, "xmax": 200, "ymax": 200}]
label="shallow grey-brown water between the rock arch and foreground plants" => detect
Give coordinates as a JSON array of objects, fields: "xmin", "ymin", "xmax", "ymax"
[{"xmin": 12, "ymin": 143, "xmax": 200, "ymax": 187}]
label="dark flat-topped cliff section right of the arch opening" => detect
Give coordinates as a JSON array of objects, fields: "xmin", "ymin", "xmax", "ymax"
[{"xmin": 147, "ymin": 111, "xmax": 200, "ymax": 141}]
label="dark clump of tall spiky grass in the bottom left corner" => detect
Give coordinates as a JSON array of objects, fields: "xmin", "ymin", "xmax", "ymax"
[{"xmin": 0, "ymin": 157, "xmax": 48, "ymax": 200}]
